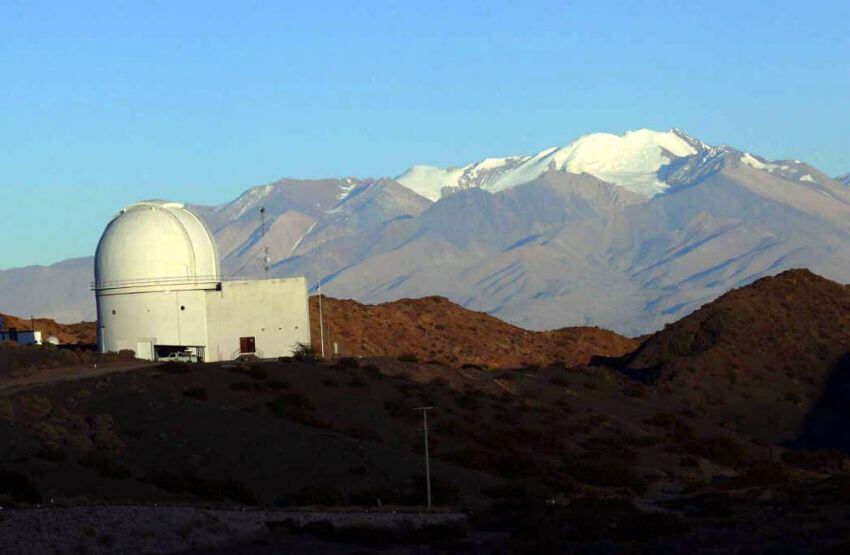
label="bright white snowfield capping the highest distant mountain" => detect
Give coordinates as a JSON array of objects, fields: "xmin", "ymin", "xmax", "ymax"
[{"xmin": 396, "ymin": 129, "xmax": 709, "ymax": 200}]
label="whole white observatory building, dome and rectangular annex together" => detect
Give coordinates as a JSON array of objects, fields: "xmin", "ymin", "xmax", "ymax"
[{"xmin": 93, "ymin": 201, "xmax": 310, "ymax": 362}]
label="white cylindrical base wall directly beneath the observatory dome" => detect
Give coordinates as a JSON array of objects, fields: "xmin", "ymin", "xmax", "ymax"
[{"xmin": 97, "ymin": 289, "xmax": 207, "ymax": 358}]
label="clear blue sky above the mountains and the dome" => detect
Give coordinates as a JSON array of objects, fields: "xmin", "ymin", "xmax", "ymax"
[{"xmin": 0, "ymin": 0, "xmax": 850, "ymax": 268}]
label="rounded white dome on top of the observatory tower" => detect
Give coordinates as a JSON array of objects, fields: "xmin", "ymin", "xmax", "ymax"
[{"xmin": 94, "ymin": 201, "xmax": 220, "ymax": 290}]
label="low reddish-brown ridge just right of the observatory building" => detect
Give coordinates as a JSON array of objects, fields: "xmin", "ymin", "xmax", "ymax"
[{"xmin": 310, "ymin": 297, "xmax": 638, "ymax": 368}]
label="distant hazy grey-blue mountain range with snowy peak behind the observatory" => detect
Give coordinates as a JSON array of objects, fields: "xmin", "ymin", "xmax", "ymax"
[{"xmin": 0, "ymin": 130, "xmax": 850, "ymax": 335}]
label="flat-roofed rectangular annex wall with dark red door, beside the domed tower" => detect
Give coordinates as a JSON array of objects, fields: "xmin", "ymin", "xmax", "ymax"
[{"xmin": 206, "ymin": 277, "xmax": 310, "ymax": 362}]
